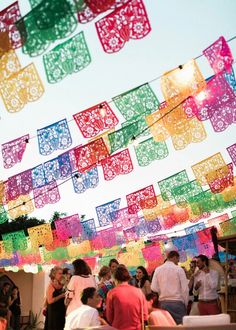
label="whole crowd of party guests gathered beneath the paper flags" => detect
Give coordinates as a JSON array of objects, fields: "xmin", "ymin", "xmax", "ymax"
[{"xmin": 40, "ymin": 251, "xmax": 221, "ymax": 330}]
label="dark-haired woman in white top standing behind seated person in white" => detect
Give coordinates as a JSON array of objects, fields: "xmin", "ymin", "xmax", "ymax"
[{"xmin": 66, "ymin": 259, "xmax": 96, "ymax": 315}]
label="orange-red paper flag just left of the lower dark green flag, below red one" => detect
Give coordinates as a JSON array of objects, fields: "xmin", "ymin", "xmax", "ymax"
[{"xmin": 74, "ymin": 138, "xmax": 109, "ymax": 173}]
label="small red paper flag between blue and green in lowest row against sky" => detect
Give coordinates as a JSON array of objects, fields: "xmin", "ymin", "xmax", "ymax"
[{"xmin": 126, "ymin": 185, "xmax": 157, "ymax": 213}]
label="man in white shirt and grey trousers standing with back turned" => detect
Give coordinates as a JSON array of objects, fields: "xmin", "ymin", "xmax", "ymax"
[{"xmin": 151, "ymin": 251, "xmax": 189, "ymax": 324}]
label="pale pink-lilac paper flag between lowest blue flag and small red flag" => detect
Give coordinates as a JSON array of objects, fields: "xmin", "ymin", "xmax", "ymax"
[{"xmin": 110, "ymin": 207, "xmax": 139, "ymax": 231}]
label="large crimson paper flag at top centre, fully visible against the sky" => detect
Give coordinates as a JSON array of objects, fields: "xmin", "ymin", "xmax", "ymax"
[{"xmin": 95, "ymin": 0, "xmax": 151, "ymax": 53}]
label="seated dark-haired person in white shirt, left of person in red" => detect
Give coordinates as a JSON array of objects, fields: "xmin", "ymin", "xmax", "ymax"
[{"xmin": 64, "ymin": 287, "xmax": 101, "ymax": 330}]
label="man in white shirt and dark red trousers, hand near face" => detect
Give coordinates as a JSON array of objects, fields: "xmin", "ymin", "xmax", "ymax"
[{"xmin": 190, "ymin": 254, "xmax": 220, "ymax": 315}]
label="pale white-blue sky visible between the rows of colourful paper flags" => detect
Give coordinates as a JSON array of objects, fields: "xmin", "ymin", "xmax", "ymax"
[{"xmin": 0, "ymin": 0, "xmax": 236, "ymax": 232}]
